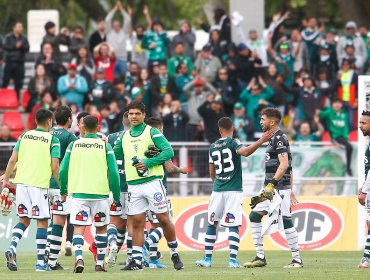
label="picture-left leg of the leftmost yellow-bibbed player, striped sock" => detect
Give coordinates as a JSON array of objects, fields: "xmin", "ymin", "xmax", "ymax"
[{"xmin": 5, "ymin": 217, "xmax": 31, "ymax": 271}]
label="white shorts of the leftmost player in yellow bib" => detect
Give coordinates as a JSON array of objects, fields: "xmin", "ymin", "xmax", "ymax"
[{"xmin": 15, "ymin": 184, "xmax": 50, "ymax": 219}]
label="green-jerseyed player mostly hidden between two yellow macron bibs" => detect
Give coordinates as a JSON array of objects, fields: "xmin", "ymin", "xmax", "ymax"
[{"xmin": 48, "ymin": 106, "xmax": 76, "ymax": 270}]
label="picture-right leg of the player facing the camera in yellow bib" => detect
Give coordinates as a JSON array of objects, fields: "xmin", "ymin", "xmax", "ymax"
[{"xmin": 156, "ymin": 212, "xmax": 184, "ymax": 270}]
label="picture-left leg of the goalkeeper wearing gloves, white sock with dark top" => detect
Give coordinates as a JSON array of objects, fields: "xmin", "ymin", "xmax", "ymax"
[{"xmin": 244, "ymin": 211, "xmax": 267, "ymax": 268}]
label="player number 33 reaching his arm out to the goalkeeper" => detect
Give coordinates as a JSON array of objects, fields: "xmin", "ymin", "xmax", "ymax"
[{"xmin": 196, "ymin": 117, "xmax": 272, "ymax": 268}]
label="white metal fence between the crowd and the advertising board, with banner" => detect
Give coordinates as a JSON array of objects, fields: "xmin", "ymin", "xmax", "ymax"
[{"xmin": 0, "ymin": 142, "xmax": 357, "ymax": 196}]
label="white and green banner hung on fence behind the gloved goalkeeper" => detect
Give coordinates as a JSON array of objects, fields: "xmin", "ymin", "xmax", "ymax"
[{"xmin": 242, "ymin": 143, "xmax": 356, "ymax": 196}]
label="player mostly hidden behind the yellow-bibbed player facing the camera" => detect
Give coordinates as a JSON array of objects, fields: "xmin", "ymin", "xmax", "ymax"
[{"xmin": 144, "ymin": 118, "xmax": 188, "ymax": 268}]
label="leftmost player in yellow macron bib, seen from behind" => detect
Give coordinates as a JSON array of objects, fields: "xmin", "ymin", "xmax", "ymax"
[{"xmin": 3, "ymin": 109, "xmax": 60, "ymax": 271}]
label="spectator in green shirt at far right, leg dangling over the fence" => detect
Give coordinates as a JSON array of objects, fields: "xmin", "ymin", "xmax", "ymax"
[{"xmin": 320, "ymin": 98, "xmax": 353, "ymax": 176}]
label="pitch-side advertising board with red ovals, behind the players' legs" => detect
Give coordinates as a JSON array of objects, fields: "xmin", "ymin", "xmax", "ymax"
[{"xmin": 0, "ymin": 196, "xmax": 366, "ymax": 252}]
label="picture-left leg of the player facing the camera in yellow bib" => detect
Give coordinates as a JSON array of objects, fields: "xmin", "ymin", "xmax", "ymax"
[{"xmin": 122, "ymin": 213, "xmax": 146, "ymax": 271}]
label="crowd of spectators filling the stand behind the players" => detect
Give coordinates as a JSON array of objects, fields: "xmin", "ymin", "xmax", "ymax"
[{"xmin": 0, "ymin": 2, "xmax": 370, "ymax": 174}]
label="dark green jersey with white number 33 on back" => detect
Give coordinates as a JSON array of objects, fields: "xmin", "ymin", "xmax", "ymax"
[{"xmin": 209, "ymin": 137, "xmax": 243, "ymax": 192}]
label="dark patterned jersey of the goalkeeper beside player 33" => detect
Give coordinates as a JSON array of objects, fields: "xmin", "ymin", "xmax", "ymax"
[{"xmin": 265, "ymin": 130, "xmax": 292, "ymax": 190}]
